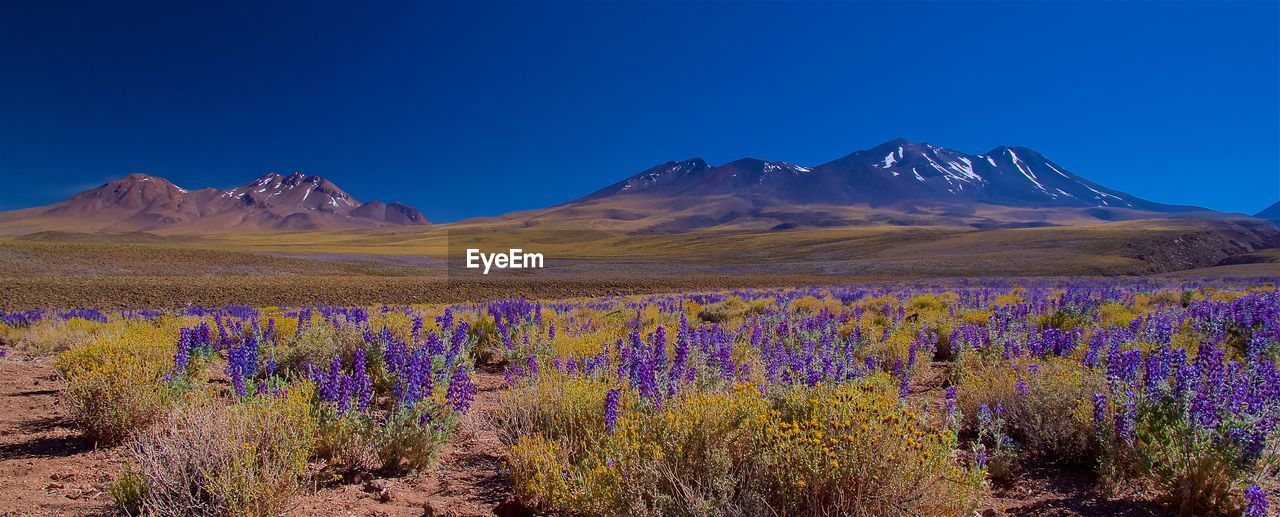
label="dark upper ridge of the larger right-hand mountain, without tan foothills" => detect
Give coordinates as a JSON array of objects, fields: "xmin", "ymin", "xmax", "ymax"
[{"xmin": 581, "ymin": 138, "xmax": 1203, "ymax": 211}]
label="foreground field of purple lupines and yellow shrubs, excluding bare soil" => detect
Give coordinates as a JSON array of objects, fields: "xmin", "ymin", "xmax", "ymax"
[{"xmin": 0, "ymin": 280, "xmax": 1280, "ymax": 516}]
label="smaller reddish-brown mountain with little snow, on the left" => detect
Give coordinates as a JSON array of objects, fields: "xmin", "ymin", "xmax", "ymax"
[{"xmin": 0, "ymin": 173, "xmax": 429, "ymax": 234}]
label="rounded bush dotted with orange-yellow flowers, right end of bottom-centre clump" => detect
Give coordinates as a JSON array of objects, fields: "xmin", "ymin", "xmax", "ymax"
[{"xmin": 760, "ymin": 374, "xmax": 983, "ymax": 516}]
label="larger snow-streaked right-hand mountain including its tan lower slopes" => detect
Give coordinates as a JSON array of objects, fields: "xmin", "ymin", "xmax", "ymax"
[{"xmin": 507, "ymin": 138, "xmax": 1208, "ymax": 230}]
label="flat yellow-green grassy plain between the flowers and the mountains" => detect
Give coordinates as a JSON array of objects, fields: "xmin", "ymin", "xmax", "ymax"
[{"xmin": 0, "ymin": 220, "xmax": 1280, "ymax": 307}]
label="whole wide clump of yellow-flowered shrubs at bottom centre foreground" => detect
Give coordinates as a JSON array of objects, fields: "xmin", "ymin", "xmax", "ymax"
[{"xmin": 498, "ymin": 374, "xmax": 983, "ymax": 514}]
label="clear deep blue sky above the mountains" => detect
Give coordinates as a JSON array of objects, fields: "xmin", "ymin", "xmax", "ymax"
[{"xmin": 0, "ymin": 0, "xmax": 1280, "ymax": 221}]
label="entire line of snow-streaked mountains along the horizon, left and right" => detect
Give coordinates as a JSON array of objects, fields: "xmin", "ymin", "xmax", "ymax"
[{"xmin": 0, "ymin": 138, "xmax": 1264, "ymax": 234}]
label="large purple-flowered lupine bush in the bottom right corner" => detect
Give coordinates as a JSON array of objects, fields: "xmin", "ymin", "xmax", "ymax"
[{"xmin": 1094, "ymin": 344, "xmax": 1280, "ymax": 514}]
